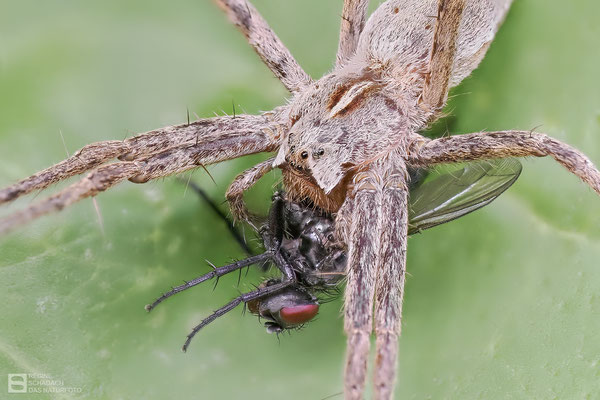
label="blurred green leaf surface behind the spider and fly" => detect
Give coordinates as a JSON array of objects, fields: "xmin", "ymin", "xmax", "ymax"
[{"xmin": 0, "ymin": 0, "xmax": 600, "ymax": 399}]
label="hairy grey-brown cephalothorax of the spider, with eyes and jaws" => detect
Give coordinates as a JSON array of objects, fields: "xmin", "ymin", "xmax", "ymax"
[{"xmin": 273, "ymin": 70, "xmax": 411, "ymax": 212}]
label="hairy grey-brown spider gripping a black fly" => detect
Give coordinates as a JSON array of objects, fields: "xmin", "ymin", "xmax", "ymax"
[{"xmin": 0, "ymin": 0, "xmax": 600, "ymax": 398}]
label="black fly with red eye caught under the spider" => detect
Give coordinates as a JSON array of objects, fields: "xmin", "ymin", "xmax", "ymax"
[{"xmin": 146, "ymin": 159, "xmax": 521, "ymax": 351}]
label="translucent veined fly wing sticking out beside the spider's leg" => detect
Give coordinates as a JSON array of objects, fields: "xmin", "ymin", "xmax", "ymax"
[{"xmin": 408, "ymin": 158, "xmax": 522, "ymax": 235}]
